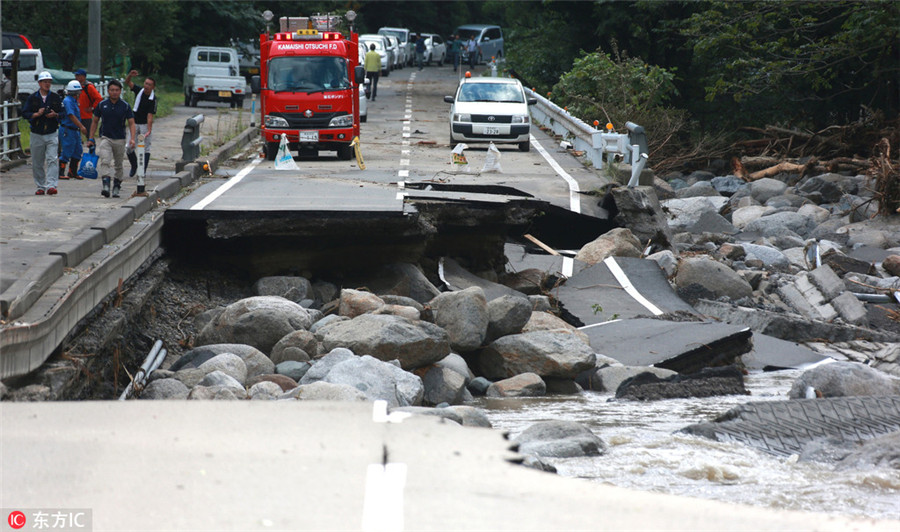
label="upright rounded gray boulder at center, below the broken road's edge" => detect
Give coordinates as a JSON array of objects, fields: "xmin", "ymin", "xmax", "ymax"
[{"xmin": 430, "ymin": 286, "xmax": 488, "ymax": 353}]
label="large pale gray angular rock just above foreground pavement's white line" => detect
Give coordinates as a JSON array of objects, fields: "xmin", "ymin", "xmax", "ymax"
[{"xmin": 323, "ymin": 355, "xmax": 424, "ymax": 407}]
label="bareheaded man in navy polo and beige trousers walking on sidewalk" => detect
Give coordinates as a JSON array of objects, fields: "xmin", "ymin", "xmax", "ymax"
[{"xmin": 88, "ymin": 79, "xmax": 135, "ymax": 198}]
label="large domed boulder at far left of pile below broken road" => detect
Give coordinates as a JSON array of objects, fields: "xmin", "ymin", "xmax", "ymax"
[{"xmin": 196, "ymin": 296, "xmax": 312, "ymax": 353}]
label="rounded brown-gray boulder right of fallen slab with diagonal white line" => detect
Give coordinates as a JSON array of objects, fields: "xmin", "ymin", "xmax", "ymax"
[{"xmin": 675, "ymin": 257, "xmax": 753, "ymax": 301}]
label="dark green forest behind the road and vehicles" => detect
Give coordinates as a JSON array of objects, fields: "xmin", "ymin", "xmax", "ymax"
[{"xmin": 2, "ymin": 0, "xmax": 900, "ymax": 168}]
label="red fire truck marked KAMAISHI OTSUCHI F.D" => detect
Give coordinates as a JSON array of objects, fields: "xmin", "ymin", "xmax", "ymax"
[{"xmin": 251, "ymin": 29, "xmax": 365, "ymax": 161}]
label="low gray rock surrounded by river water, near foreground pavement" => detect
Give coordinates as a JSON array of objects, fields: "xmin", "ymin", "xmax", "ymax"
[{"xmin": 512, "ymin": 420, "xmax": 606, "ymax": 458}]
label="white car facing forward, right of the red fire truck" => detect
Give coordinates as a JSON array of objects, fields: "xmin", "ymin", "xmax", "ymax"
[{"xmin": 444, "ymin": 78, "xmax": 537, "ymax": 151}]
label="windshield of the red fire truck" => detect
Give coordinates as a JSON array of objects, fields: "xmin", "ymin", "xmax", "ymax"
[{"xmin": 268, "ymin": 56, "xmax": 350, "ymax": 92}]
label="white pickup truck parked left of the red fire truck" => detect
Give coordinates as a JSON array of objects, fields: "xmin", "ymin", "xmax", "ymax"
[{"xmin": 184, "ymin": 46, "xmax": 248, "ymax": 107}]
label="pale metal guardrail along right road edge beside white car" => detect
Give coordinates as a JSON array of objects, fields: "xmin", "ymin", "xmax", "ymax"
[{"xmin": 525, "ymin": 89, "xmax": 648, "ymax": 187}]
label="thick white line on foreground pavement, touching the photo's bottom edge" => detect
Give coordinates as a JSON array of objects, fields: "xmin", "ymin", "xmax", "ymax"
[{"xmin": 362, "ymin": 463, "xmax": 408, "ymax": 532}]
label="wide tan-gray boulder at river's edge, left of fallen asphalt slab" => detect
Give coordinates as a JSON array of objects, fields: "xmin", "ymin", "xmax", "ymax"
[{"xmin": 478, "ymin": 330, "xmax": 595, "ymax": 379}]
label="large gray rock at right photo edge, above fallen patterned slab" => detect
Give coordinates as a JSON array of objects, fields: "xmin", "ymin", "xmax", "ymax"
[{"xmin": 788, "ymin": 362, "xmax": 900, "ymax": 399}]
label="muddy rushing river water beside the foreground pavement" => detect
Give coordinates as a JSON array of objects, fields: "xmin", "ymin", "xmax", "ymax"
[{"xmin": 476, "ymin": 370, "xmax": 900, "ymax": 519}]
